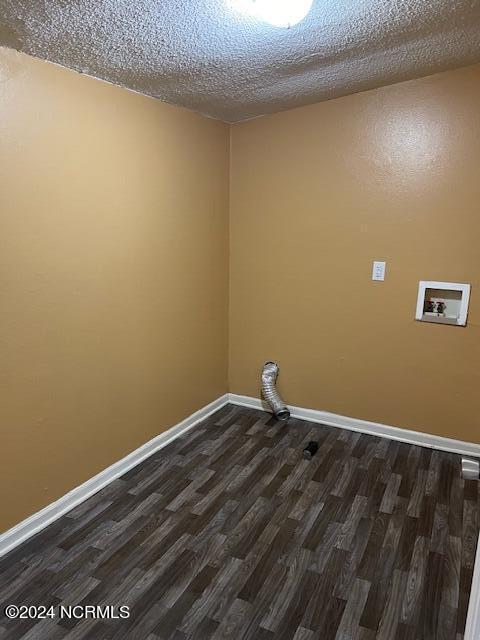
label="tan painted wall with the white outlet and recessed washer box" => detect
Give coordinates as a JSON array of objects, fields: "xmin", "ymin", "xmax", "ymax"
[{"xmin": 229, "ymin": 65, "xmax": 480, "ymax": 442}]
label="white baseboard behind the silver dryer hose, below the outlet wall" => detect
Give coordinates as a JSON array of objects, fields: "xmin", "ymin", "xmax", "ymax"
[{"xmin": 228, "ymin": 393, "xmax": 480, "ymax": 458}]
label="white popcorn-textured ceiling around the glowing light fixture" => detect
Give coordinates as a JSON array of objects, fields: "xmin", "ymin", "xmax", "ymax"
[{"xmin": 0, "ymin": 0, "xmax": 480, "ymax": 122}]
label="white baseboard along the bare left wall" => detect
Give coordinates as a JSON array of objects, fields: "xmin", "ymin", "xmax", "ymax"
[{"xmin": 0, "ymin": 393, "xmax": 229, "ymax": 557}]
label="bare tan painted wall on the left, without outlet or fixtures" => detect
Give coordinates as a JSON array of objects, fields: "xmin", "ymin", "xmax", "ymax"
[{"xmin": 0, "ymin": 49, "xmax": 228, "ymax": 530}]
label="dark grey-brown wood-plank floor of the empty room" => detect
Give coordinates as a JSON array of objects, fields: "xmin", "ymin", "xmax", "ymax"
[{"xmin": 0, "ymin": 405, "xmax": 479, "ymax": 640}]
